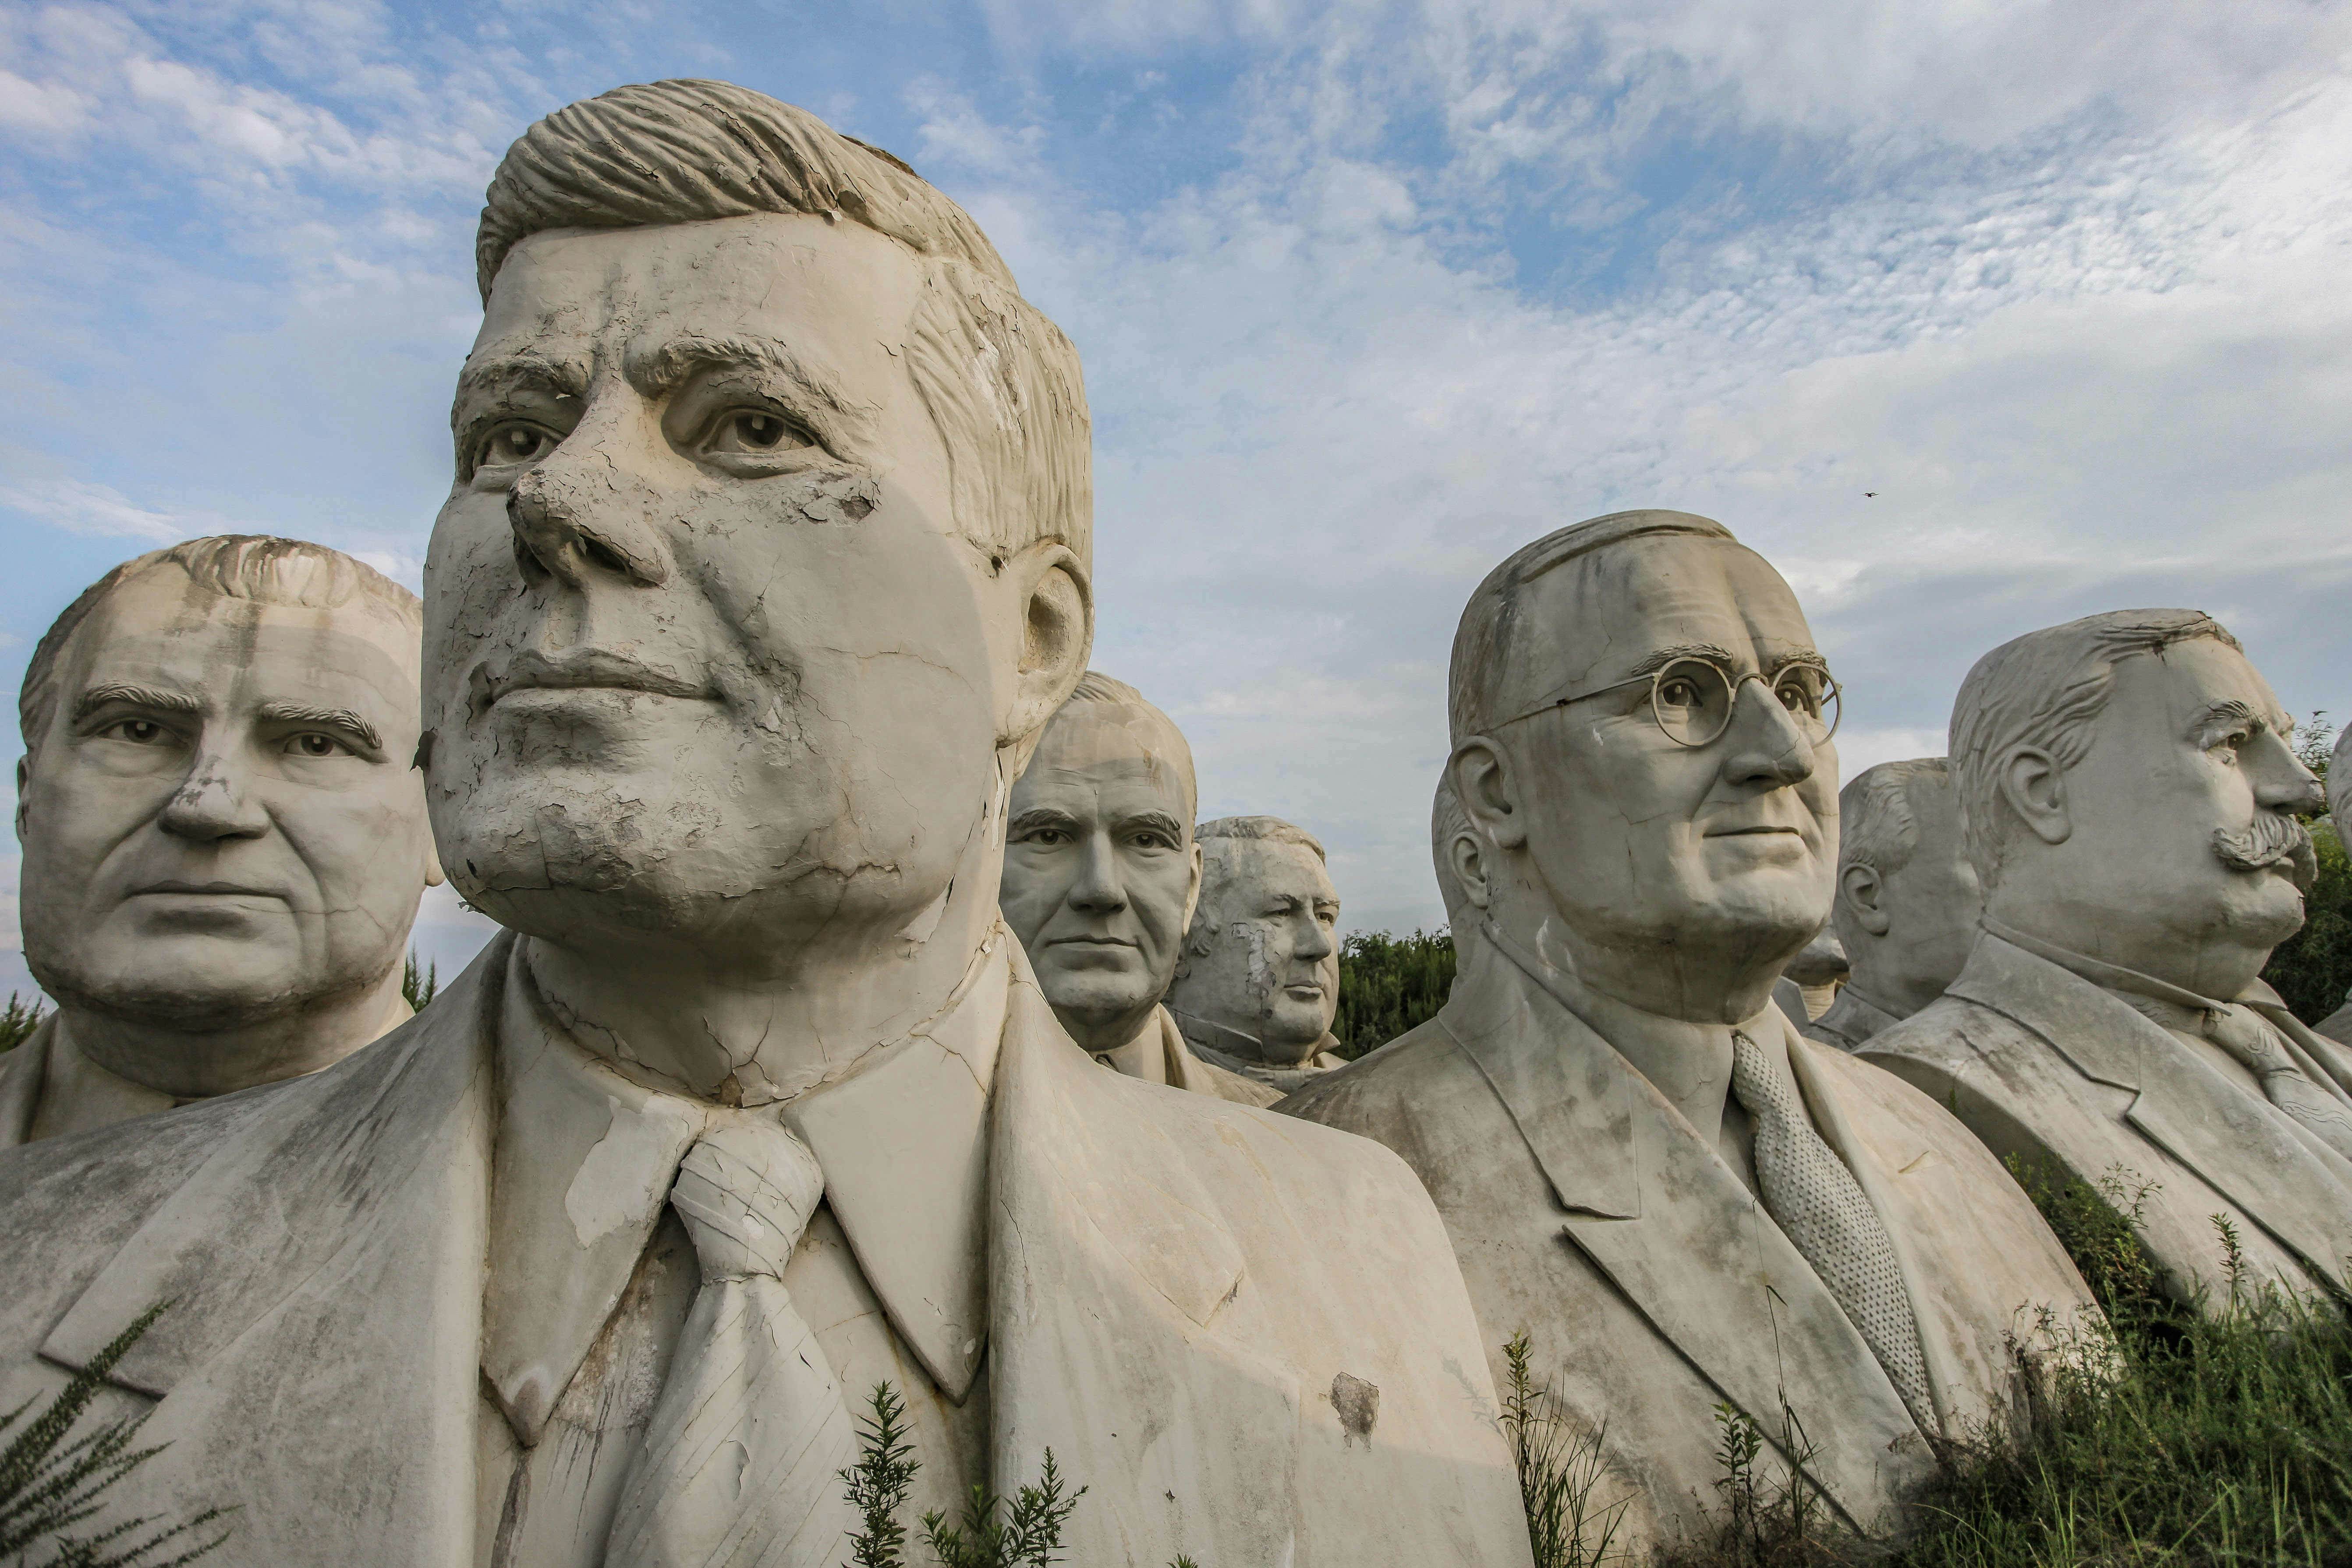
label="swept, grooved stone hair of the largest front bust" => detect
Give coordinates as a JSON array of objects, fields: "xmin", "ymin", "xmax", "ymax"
[{"xmin": 475, "ymin": 80, "xmax": 1094, "ymax": 569}]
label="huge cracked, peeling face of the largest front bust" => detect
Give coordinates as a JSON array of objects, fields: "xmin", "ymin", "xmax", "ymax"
[{"xmin": 426, "ymin": 214, "xmax": 1037, "ymax": 966}]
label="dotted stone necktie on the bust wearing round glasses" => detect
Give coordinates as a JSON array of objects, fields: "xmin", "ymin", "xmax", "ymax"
[{"xmin": 1731, "ymin": 1030, "xmax": 1938, "ymax": 1434}]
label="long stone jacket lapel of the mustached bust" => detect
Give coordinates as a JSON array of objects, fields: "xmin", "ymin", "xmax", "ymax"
[{"xmin": 1950, "ymin": 931, "xmax": 2352, "ymax": 1279}]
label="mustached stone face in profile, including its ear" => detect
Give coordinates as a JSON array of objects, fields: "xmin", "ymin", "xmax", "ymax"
[{"xmin": 1994, "ymin": 637, "xmax": 2321, "ymax": 997}]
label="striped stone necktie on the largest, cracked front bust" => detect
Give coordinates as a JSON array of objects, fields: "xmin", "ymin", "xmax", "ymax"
[{"xmin": 605, "ymin": 1117, "xmax": 858, "ymax": 1568}]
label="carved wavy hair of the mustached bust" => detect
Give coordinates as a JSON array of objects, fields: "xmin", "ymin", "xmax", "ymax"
[{"xmin": 1950, "ymin": 609, "xmax": 2239, "ymax": 888}]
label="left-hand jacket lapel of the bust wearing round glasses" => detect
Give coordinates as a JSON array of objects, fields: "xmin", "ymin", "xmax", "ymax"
[{"xmin": 1446, "ymin": 957, "xmax": 1917, "ymax": 1523}]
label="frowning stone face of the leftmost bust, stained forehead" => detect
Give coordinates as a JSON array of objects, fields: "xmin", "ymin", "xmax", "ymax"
[{"xmin": 17, "ymin": 566, "xmax": 437, "ymax": 1095}]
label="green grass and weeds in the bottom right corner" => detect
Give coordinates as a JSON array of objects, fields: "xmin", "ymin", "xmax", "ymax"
[{"xmin": 1900, "ymin": 1173, "xmax": 2352, "ymax": 1568}]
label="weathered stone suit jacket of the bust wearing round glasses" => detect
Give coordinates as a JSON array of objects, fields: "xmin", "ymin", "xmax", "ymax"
[{"xmin": 1282, "ymin": 943, "xmax": 2096, "ymax": 1551}]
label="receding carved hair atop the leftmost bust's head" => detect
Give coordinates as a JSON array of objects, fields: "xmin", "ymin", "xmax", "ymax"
[{"xmin": 17, "ymin": 534, "xmax": 426, "ymax": 752}]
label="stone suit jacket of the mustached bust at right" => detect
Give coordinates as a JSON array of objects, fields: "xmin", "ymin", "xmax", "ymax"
[{"xmin": 1863, "ymin": 931, "xmax": 2352, "ymax": 1303}]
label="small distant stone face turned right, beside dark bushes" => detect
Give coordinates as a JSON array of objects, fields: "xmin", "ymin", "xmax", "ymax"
[{"xmin": 1171, "ymin": 839, "xmax": 1338, "ymax": 1067}]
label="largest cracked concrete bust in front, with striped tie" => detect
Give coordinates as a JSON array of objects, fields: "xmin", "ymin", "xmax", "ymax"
[{"xmin": 0, "ymin": 82, "xmax": 1527, "ymax": 1568}]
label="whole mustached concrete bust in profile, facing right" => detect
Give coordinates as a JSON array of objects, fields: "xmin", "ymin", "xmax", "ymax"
[{"xmin": 1865, "ymin": 609, "xmax": 2352, "ymax": 1300}]
